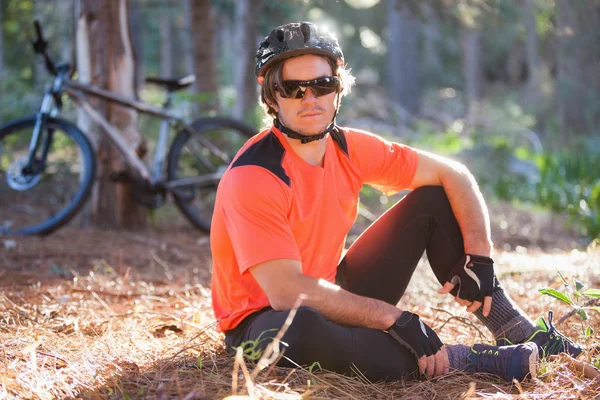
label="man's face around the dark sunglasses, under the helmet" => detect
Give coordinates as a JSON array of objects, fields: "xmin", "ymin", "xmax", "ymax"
[{"xmin": 275, "ymin": 54, "xmax": 336, "ymax": 135}]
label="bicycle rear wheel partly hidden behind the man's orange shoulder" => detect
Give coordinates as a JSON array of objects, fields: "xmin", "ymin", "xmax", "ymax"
[{"xmin": 167, "ymin": 118, "xmax": 257, "ymax": 232}]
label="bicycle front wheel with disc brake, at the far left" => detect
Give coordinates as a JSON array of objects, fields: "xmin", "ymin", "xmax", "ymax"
[{"xmin": 0, "ymin": 117, "xmax": 96, "ymax": 236}]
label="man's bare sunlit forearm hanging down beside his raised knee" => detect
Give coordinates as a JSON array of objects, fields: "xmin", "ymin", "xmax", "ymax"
[{"xmin": 441, "ymin": 163, "xmax": 492, "ymax": 256}]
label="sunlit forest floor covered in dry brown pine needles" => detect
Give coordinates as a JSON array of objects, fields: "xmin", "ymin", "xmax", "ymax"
[{"xmin": 0, "ymin": 204, "xmax": 600, "ymax": 399}]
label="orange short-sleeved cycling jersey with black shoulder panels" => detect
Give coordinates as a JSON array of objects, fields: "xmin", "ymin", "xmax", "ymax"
[{"xmin": 210, "ymin": 127, "xmax": 417, "ymax": 332}]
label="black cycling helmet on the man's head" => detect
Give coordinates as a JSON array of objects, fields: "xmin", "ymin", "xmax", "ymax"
[{"xmin": 254, "ymin": 22, "xmax": 344, "ymax": 83}]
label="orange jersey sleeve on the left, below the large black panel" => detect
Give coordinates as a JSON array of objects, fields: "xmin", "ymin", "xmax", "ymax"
[{"xmin": 221, "ymin": 166, "xmax": 301, "ymax": 273}]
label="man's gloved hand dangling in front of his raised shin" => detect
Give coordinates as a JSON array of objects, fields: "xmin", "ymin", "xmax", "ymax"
[{"xmin": 438, "ymin": 254, "xmax": 498, "ymax": 317}]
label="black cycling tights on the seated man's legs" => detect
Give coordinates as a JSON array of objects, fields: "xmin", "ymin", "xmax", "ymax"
[{"xmin": 225, "ymin": 186, "xmax": 464, "ymax": 382}]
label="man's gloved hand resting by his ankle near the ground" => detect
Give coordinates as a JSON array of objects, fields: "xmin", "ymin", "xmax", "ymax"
[{"xmin": 387, "ymin": 311, "xmax": 450, "ymax": 379}]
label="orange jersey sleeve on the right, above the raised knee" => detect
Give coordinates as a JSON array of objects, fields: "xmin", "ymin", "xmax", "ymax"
[{"xmin": 349, "ymin": 130, "xmax": 418, "ymax": 195}]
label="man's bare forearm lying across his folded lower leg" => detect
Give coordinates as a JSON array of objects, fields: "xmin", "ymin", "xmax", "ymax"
[{"xmin": 273, "ymin": 275, "xmax": 402, "ymax": 330}]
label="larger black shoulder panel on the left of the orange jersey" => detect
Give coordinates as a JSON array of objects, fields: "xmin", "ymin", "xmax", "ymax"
[{"xmin": 231, "ymin": 132, "xmax": 291, "ymax": 186}]
